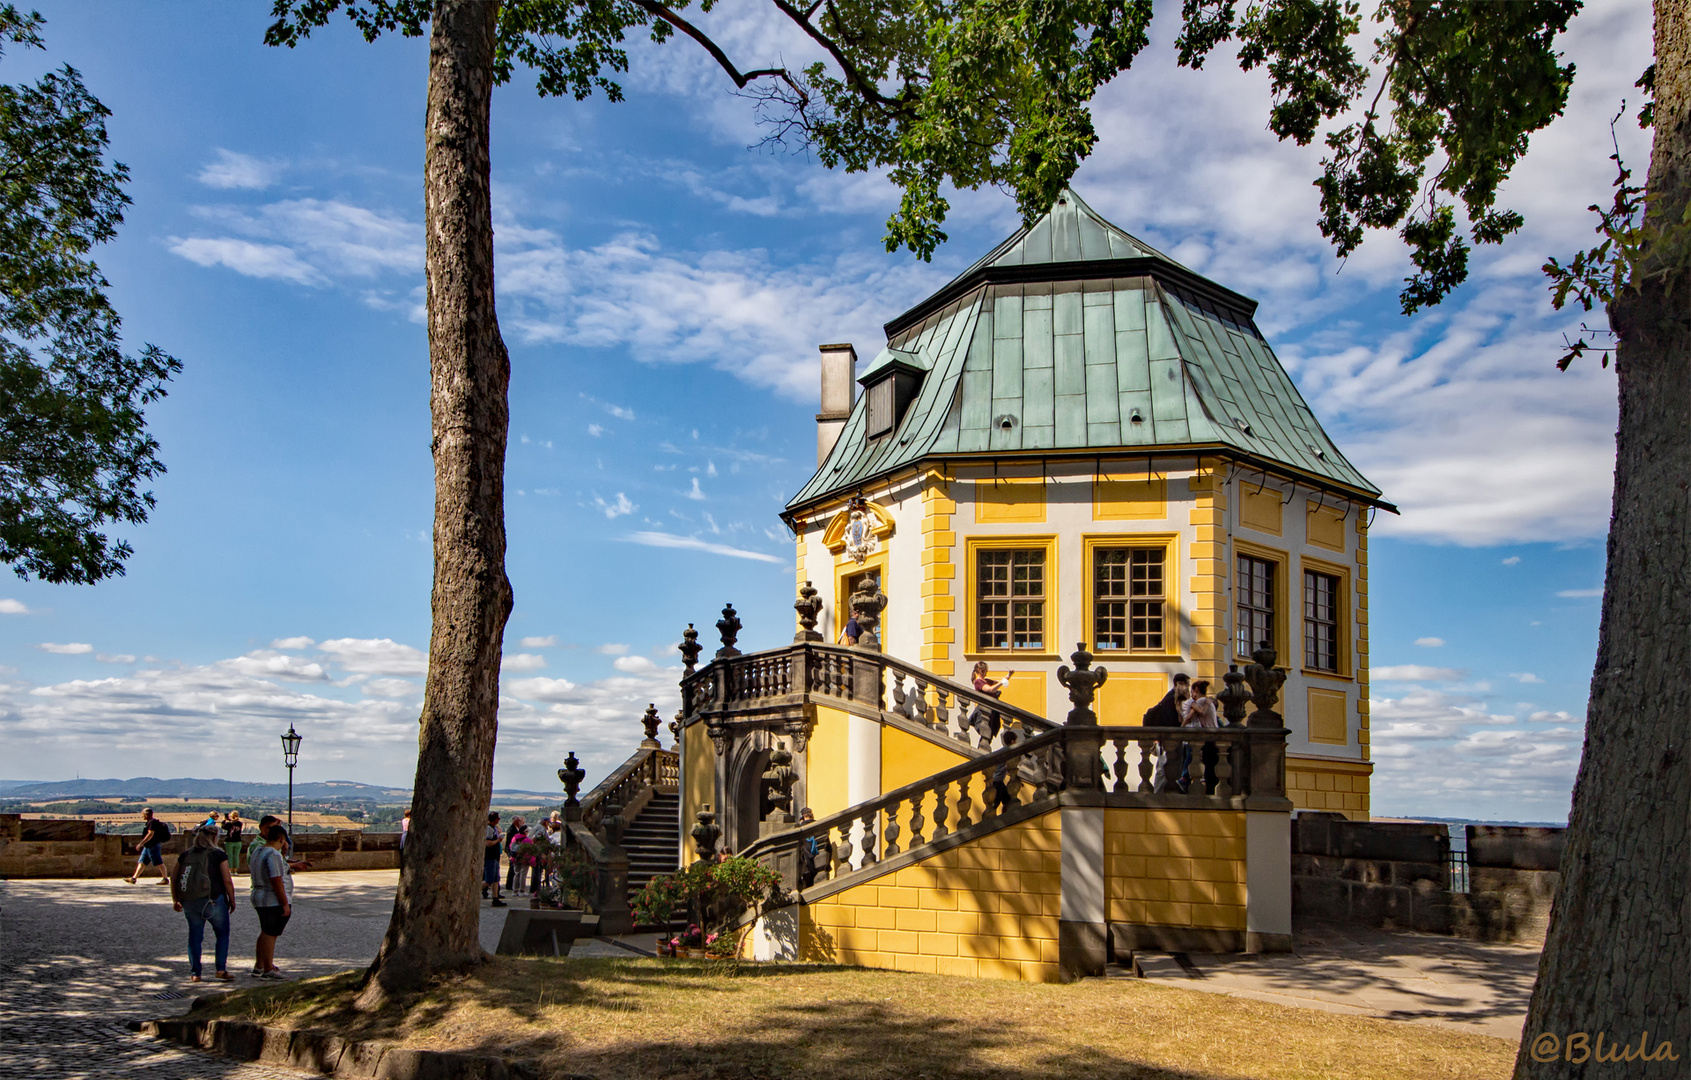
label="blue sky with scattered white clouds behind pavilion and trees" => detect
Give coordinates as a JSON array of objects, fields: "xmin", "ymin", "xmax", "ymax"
[{"xmin": 0, "ymin": 0, "xmax": 1650, "ymax": 820}]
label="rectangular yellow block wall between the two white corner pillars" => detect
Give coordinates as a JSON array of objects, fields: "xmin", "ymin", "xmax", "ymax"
[{"xmin": 1104, "ymin": 810, "xmax": 1245, "ymax": 930}]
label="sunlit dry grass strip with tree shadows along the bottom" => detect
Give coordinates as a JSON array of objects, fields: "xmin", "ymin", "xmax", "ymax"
[{"xmin": 196, "ymin": 958, "xmax": 1515, "ymax": 1080}]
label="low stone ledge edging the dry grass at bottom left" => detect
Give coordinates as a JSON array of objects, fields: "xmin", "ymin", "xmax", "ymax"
[{"xmin": 129, "ymin": 1017, "xmax": 594, "ymax": 1080}]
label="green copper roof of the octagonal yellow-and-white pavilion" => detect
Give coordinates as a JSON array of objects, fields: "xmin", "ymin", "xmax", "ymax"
[{"xmin": 788, "ymin": 193, "xmax": 1390, "ymax": 509}]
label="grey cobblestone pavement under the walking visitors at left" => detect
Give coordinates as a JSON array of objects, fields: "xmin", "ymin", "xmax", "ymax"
[{"xmin": 0, "ymin": 870, "xmax": 504, "ymax": 1080}]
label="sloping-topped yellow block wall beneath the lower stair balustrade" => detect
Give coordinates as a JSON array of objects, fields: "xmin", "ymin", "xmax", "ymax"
[{"xmin": 800, "ymin": 810, "xmax": 1061, "ymax": 982}]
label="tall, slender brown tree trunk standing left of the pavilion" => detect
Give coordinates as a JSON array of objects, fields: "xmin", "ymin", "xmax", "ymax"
[{"xmin": 367, "ymin": 0, "xmax": 511, "ymax": 1001}]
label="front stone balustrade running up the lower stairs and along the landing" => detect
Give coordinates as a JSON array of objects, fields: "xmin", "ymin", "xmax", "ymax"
[{"xmin": 741, "ymin": 725, "xmax": 1289, "ymax": 886}]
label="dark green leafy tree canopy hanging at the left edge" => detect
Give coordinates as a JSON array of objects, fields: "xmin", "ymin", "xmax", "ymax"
[{"xmin": 0, "ymin": 5, "xmax": 181, "ymax": 583}]
